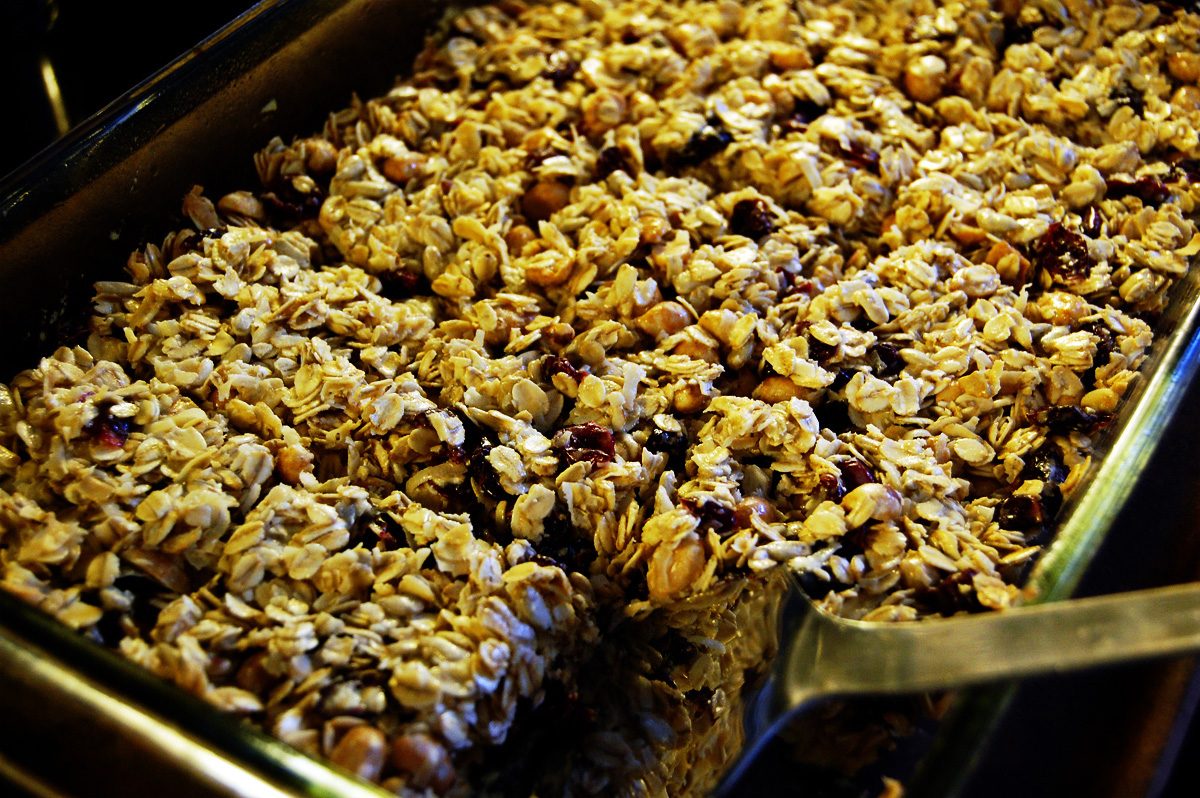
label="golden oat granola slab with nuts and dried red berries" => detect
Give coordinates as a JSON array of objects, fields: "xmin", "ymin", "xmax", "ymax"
[{"xmin": 0, "ymin": 0, "xmax": 1200, "ymax": 796}]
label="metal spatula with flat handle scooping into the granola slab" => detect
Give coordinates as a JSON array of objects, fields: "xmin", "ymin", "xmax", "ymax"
[{"xmin": 718, "ymin": 583, "xmax": 1200, "ymax": 796}]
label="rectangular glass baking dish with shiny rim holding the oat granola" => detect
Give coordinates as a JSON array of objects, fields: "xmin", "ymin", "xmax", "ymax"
[{"xmin": 0, "ymin": 0, "xmax": 1200, "ymax": 797}]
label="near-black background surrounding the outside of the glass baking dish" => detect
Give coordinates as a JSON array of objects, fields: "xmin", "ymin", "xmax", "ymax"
[{"xmin": 7, "ymin": 0, "xmax": 1200, "ymax": 798}]
